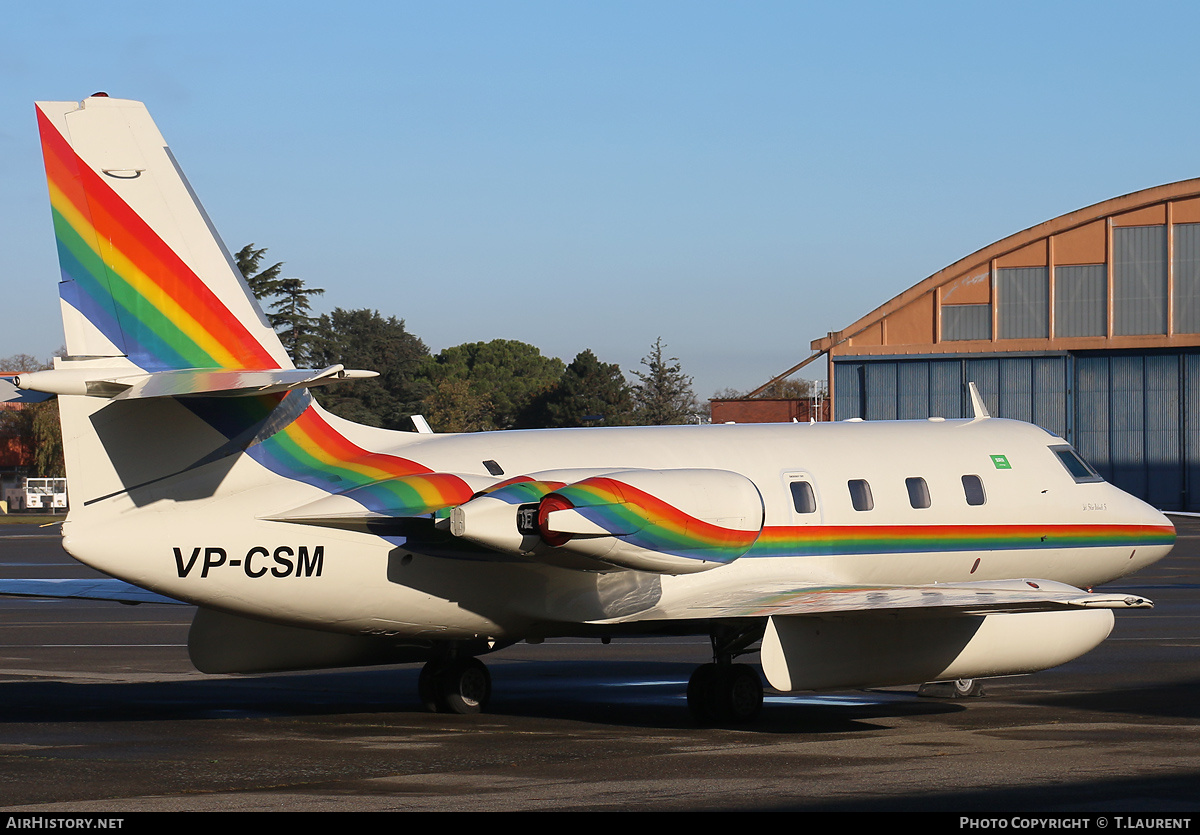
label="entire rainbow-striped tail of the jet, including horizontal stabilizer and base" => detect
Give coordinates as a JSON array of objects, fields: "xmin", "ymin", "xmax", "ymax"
[{"xmin": 29, "ymin": 95, "xmax": 384, "ymax": 518}]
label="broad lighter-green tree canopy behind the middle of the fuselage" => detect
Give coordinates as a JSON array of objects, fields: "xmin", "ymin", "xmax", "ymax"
[{"xmin": 424, "ymin": 340, "xmax": 563, "ymax": 429}]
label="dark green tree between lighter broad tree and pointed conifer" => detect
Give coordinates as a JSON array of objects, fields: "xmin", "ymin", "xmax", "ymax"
[{"xmin": 526, "ymin": 350, "xmax": 634, "ymax": 427}]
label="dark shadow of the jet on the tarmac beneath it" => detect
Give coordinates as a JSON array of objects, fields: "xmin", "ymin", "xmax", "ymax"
[{"xmin": 0, "ymin": 661, "xmax": 966, "ymax": 733}]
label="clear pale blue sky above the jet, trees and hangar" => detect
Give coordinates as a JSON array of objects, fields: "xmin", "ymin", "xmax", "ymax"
[{"xmin": 0, "ymin": 0, "xmax": 1200, "ymax": 397}]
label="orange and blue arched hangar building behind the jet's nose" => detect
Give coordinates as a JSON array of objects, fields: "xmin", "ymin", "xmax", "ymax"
[{"xmin": 812, "ymin": 179, "xmax": 1200, "ymax": 510}]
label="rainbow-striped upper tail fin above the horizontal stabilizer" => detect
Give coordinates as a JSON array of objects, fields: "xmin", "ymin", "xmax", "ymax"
[{"xmin": 37, "ymin": 96, "xmax": 292, "ymax": 371}]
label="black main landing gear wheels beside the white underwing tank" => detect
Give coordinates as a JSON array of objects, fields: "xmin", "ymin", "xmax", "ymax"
[{"xmin": 688, "ymin": 624, "xmax": 766, "ymax": 725}]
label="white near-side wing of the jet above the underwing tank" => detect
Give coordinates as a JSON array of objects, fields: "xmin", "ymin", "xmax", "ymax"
[{"xmin": 590, "ymin": 579, "xmax": 1154, "ymax": 619}]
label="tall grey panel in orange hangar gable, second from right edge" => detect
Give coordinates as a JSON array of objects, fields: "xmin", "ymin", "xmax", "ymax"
[{"xmin": 1112, "ymin": 226, "xmax": 1166, "ymax": 336}]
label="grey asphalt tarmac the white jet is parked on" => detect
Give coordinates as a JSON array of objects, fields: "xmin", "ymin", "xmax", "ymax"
[{"xmin": 0, "ymin": 521, "xmax": 1200, "ymax": 816}]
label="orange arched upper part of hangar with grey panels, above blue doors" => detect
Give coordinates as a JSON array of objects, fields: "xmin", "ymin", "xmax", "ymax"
[{"xmin": 812, "ymin": 179, "xmax": 1200, "ymax": 356}]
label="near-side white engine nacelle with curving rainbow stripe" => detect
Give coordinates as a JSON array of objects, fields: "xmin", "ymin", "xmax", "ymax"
[{"xmin": 450, "ymin": 469, "xmax": 764, "ymax": 573}]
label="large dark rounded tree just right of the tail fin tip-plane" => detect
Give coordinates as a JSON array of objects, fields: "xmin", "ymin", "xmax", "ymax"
[{"xmin": 312, "ymin": 307, "xmax": 432, "ymax": 429}]
